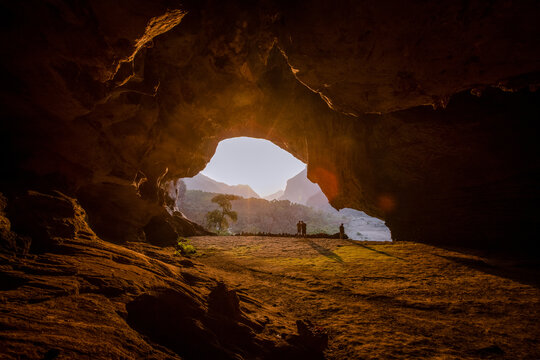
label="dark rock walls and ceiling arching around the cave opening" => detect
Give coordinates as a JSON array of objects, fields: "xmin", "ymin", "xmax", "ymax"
[{"xmin": 0, "ymin": 0, "xmax": 540, "ymax": 252}]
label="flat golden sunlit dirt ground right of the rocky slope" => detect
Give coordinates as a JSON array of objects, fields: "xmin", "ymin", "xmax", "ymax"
[{"xmin": 187, "ymin": 236, "xmax": 540, "ymax": 359}]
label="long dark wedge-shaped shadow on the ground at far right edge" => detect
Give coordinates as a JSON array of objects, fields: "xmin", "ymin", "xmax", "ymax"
[{"xmin": 437, "ymin": 255, "xmax": 540, "ymax": 288}]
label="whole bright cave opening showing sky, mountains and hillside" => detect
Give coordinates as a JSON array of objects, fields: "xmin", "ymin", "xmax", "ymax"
[{"xmin": 178, "ymin": 137, "xmax": 391, "ymax": 241}]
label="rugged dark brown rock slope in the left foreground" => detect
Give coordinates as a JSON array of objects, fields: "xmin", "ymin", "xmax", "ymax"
[{"xmin": 0, "ymin": 192, "xmax": 322, "ymax": 359}]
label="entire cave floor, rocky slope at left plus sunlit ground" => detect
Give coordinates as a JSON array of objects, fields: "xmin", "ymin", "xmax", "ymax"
[{"xmin": 0, "ymin": 222, "xmax": 540, "ymax": 359}]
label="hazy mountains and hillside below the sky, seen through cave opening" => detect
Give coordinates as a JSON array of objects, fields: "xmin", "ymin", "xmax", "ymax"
[{"xmin": 182, "ymin": 170, "xmax": 391, "ymax": 241}]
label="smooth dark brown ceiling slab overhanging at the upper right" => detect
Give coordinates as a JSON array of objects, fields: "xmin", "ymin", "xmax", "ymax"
[{"xmin": 279, "ymin": 0, "xmax": 539, "ymax": 116}]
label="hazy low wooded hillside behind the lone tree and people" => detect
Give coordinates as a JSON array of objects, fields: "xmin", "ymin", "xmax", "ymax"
[{"xmin": 180, "ymin": 190, "xmax": 343, "ymax": 234}]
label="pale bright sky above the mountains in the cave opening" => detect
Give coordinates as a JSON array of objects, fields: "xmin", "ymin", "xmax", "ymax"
[{"xmin": 201, "ymin": 137, "xmax": 306, "ymax": 196}]
